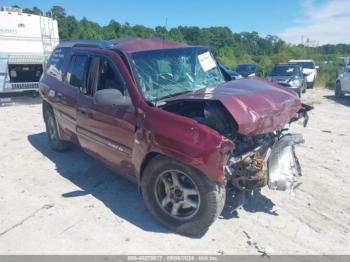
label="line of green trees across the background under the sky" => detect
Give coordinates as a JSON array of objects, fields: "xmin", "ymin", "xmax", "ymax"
[{"xmin": 17, "ymin": 6, "xmax": 350, "ymax": 86}]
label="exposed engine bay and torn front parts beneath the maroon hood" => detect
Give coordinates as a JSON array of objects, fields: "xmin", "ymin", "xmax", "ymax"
[{"xmin": 162, "ymin": 100, "xmax": 312, "ymax": 191}]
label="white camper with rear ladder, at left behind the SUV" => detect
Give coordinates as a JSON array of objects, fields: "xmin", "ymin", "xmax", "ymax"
[{"xmin": 0, "ymin": 7, "xmax": 59, "ymax": 93}]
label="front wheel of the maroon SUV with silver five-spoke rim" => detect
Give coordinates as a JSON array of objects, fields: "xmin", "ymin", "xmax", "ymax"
[{"xmin": 141, "ymin": 156, "xmax": 226, "ymax": 235}]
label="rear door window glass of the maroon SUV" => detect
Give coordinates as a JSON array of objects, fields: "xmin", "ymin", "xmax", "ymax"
[{"xmin": 67, "ymin": 55, "xmax": 89, "ymax": 88}]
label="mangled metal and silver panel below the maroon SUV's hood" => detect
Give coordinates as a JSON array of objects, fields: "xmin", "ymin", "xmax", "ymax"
[{"xmin": 225, "ymin": 134, "xmax": 304, "ymax": 191}]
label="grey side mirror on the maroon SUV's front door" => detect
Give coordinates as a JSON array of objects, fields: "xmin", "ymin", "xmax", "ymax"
[{"xmin": 94, "ymin": 89, "xmax": 132, "ymax": 107}]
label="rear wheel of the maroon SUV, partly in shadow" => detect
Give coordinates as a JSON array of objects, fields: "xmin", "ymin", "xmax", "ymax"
[{"xmin": 44, "ymin": 108, "xmax": 70, "ymax": 152}]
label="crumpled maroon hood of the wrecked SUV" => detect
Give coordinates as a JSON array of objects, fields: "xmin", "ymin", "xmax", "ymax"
[{"xmin": 165, "ymin": 77, "xmax": 301, "ymax": 135}]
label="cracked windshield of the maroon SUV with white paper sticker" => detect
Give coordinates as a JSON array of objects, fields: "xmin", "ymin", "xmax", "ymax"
[{"xmin": 131, "ymin": 47, "xmax": 225, "ymax": 101}]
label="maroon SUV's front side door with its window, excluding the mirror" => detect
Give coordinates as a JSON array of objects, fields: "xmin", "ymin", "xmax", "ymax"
[{"xmin": 77, "ymin": 56, "xmax": 135, "ymax": 179}]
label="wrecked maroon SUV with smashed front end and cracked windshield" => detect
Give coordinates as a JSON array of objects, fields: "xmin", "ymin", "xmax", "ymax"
[{"xmin": 40, "ymin": 39, "xmax": 310, "ymax": 234}]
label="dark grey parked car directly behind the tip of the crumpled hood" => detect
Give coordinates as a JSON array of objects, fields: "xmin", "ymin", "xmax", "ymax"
[{"xmin": 266, "ymin": 63, "xmax": 307, "ymax": 96}]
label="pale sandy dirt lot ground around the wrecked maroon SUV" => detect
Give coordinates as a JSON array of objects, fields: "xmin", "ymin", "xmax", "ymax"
[{"xmin": 0, "ymin": 89, "xmax": 350, "ymax": 254}]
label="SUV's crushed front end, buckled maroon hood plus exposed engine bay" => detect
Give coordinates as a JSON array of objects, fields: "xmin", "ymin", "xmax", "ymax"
[{"xmin": 155, "ymin": 74, "xmax": 312, "ymax": 191}]
